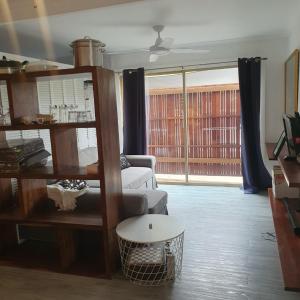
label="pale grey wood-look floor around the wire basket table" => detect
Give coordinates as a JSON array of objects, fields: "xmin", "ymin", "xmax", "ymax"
[{"xmin": 0, "ymin": 186, "xmax": 300, "ymax": 300}]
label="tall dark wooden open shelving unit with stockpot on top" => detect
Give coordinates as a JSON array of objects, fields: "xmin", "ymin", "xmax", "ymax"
[{"xmin": 0, "ymin": 67, "xmax": 122, "ymax": 278}]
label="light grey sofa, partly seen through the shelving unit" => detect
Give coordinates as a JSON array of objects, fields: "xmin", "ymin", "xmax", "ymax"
[{"xmin": 77, "ymin": 148, "xmax": 168, "ymax": 218}]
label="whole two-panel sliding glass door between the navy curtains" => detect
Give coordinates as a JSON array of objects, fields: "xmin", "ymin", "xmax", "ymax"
[{"xmin": 146, "ymin": 68, "xmax": 241, "ymax": 183}]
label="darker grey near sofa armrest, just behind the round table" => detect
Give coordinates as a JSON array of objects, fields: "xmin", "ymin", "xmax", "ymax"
[{"xmin": 122, "ymin": 189, "xmax": 148, "ymax": 218}]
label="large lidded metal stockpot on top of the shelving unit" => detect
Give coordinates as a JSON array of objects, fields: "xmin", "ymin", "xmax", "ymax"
[{"xmin": 70, "ymin": 36, "xmax": 105, "ymax": 67}]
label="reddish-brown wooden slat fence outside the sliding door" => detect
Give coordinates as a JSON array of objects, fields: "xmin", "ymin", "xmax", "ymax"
[{"xmin": 148, "ymin": 84, "xmax": 241, "ymax": 176}]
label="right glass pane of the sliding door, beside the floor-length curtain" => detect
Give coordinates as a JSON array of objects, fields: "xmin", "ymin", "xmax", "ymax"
[{"xmin": 186, "ymin": 68, "xmax": 241, "ymax": 183}]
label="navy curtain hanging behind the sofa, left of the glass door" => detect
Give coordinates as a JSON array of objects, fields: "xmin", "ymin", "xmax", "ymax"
[{"xmin": 123, "ymin": 68, "xmax": 147, "ymax": 154}]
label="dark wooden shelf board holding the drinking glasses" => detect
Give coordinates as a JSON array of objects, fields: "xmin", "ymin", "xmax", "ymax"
[{"xmin": 0, "ymin": 121, "xmax": 96, "ymax": 131}]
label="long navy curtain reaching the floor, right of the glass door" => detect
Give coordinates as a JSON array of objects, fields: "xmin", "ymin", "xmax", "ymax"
[{"xmin": 238, "ymin": 57, "xmax": 272, "ymax": 194}]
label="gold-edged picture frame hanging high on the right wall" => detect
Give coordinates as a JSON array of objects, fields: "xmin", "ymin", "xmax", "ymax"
[{"xmin": 284, "ymin": 49, "xmax": 300, "ymax": 115}]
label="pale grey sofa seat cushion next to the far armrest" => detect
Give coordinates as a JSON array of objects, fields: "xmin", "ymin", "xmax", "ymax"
[{"xmin": 121, "ymin": 167, "xmax": 154, "ymax": 189}]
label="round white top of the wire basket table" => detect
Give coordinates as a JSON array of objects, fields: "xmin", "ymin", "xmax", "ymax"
[{"xmin": 116, "ymin": 214, "xmax": 184, "ymax": 243}]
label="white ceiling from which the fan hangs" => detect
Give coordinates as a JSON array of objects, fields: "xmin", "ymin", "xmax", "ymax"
[{"xmin": 0, "ymin": 0, "xmax": 300, "ymax": 62}]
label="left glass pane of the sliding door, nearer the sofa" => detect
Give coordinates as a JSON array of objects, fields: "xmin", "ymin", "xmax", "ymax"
[{"xmin": 146, "ymin": 74, "xmax": 185, "ymax": 181}]
